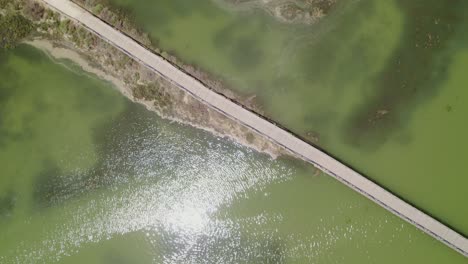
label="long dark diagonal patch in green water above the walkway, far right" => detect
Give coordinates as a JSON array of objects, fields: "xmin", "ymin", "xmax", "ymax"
[{"xmin": 342, "ymin": 0, "xmax": 462, "ymax": 150}]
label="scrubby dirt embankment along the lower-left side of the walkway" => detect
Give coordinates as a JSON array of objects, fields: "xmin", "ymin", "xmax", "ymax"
[{"xmin": 22, "ymin": 0, "xmax": 288, "ymax": 157}]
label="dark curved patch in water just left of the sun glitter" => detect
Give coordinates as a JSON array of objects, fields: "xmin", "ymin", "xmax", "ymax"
[{"xmin": 33, "ymin": 102, "xmax": 168, "ymax": 209}]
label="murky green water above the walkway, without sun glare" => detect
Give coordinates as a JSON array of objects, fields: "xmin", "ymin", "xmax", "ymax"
[{"xmin": 111, "ymin": 0, "xmax": 468, "ymax": 234}]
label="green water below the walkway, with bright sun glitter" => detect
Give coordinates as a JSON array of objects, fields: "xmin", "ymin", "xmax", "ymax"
[{"xmin": 0, "ymin": 46, "xmax": 466, "ymax": 264}]
